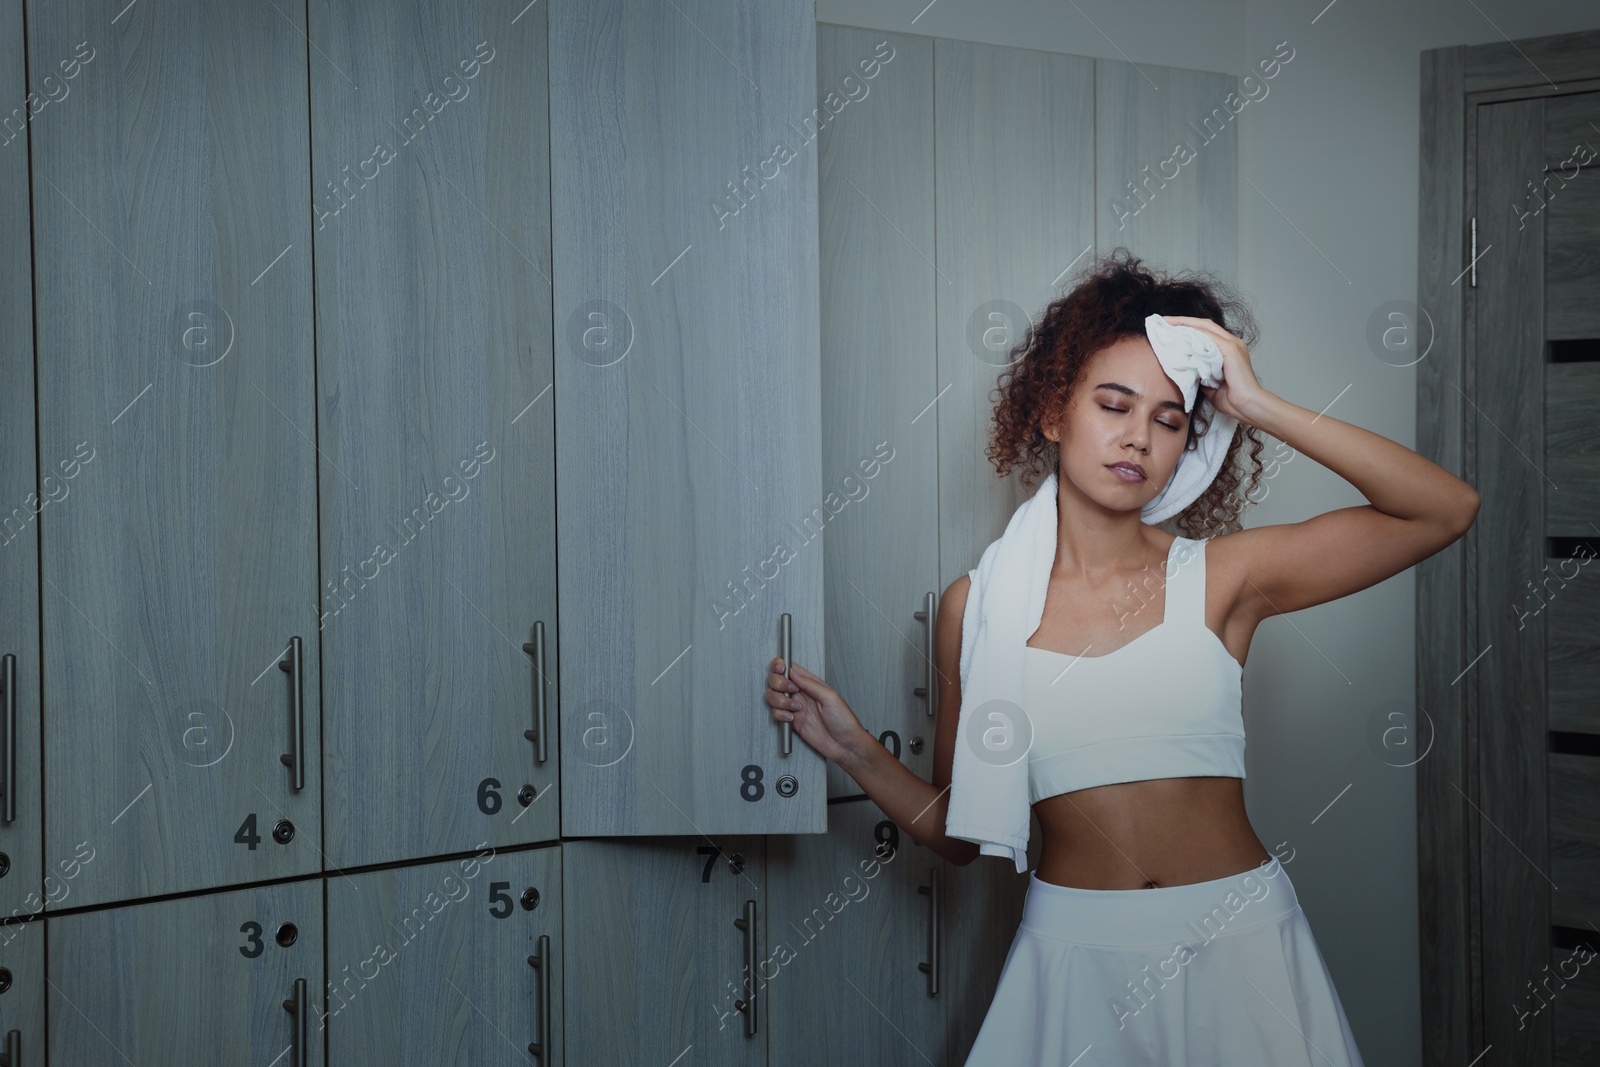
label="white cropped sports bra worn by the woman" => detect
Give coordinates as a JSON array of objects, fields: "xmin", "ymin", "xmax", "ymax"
[{"xmin": 1022, "ymin": 537, "xmax": 1245, "ymax": 803}]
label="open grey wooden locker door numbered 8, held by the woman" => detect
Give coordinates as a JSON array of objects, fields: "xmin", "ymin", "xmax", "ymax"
[{"xmin": 550, "ymin": 0, "xmax": 825, "ymax": 837}]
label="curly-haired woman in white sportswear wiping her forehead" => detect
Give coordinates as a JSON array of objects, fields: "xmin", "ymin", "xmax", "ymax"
[{"xmin": 766, "ymin": 256, "xmax": 1478, "ymax": 1067}]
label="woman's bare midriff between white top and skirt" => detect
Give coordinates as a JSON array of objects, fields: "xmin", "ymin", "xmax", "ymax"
[{"xmin": 1034, "ymin": 776, "xmax": 1272, "ymax": 889}]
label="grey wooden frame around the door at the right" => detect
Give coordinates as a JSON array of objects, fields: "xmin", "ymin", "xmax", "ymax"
[{"xmin": 1416, "ymin": 30, "xmax": 1600, "ymax": 1067}]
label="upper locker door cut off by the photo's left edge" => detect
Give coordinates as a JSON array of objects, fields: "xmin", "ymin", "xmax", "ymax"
[{"xmin": 0, "ymin": 0, "xmax": 42, "ymax": 927}]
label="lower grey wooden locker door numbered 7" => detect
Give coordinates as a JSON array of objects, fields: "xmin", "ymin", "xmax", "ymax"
[{"xmin": 562, "ymin": 837, "xmax": 764, "ymax": 1067}]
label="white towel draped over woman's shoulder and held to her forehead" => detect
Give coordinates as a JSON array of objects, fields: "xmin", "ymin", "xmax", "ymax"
[{"xmin": 944, "ymin": 315, "xmax": 1238, "ymax": 873}]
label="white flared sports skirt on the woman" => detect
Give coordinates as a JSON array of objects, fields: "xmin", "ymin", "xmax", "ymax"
[{"xmin": 966, "ymin": 859, "xmax": 1363, "ymax": 1067}]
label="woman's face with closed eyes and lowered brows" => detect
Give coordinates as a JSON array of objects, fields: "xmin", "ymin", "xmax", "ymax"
[{"xmin": 1045, "ymin": 336, "xmax": 1189, "ymax": 510}]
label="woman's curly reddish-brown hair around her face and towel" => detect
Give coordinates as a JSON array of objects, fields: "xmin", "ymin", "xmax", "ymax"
[{"xmin": 987, "ymin": 248, "xmax": 1262, "ymax": 539}]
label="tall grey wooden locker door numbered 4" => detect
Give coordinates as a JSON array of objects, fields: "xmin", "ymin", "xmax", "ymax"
[{"xmin": 24, "ymin": 0, "xmax": 322, "ymax": 907}]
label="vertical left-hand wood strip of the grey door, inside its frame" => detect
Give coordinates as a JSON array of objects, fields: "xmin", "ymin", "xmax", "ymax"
[{"xmin": 1474, "ymin": 99, "xmax": 1552, "ymax": 1064}]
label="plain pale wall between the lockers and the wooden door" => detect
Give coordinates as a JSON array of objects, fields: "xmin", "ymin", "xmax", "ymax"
[{"xmin": 816, "ymin": 0, "xmax": 1600, "ymax": 1067}]
